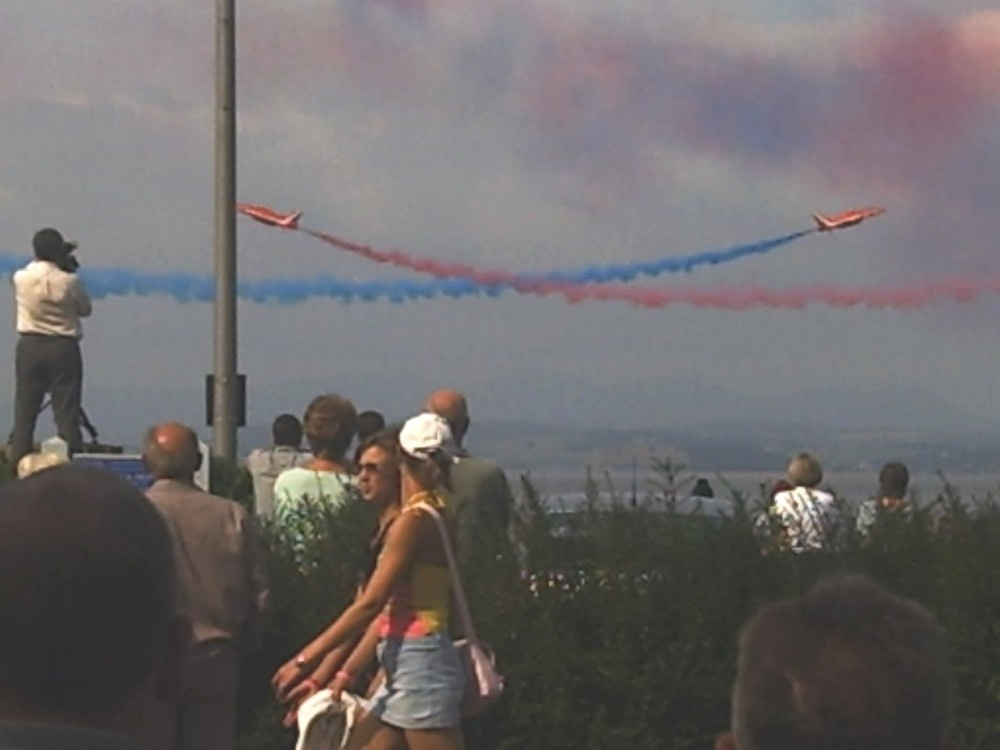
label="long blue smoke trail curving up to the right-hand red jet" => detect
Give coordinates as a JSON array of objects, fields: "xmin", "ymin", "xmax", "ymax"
[{"xmin": 0, "ymin": 230, "xmax": 812, "ymax": 305}]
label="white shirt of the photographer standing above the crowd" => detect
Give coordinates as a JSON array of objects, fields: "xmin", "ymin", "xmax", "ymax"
[{"xmin": 14, "ymin": 260, "xmax": 92, "ymax": 339}]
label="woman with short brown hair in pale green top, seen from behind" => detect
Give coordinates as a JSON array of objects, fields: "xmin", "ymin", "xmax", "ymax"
[{"xmin": 274, "ymin": 393, "xmax": 358, "ymax": 525}]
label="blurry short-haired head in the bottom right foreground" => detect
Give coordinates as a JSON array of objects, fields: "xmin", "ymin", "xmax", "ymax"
[{"xmin": 716, "ymin": 576, "xmax": 953, "ymax": 750}]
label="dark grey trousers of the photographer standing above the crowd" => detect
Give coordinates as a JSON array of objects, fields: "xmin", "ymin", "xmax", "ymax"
[{"xmin": 11, "ymin": 334, "xmax": 83, "ymax": 463}]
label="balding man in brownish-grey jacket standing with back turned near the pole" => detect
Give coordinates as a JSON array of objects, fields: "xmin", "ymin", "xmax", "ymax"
[{"xmin": 143, "ymin": 423, "xmax": 269, "ymax": 750}]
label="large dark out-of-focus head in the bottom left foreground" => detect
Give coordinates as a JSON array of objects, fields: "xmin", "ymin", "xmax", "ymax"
[{"xmin": 0, "ymin": 466, "xmax": 177, "ymax": 719}]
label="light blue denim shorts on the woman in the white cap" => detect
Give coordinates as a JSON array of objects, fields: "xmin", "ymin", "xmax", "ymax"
[{"xmin": 368, "ymin": 633, "xmax": 465, "ymax": 729}]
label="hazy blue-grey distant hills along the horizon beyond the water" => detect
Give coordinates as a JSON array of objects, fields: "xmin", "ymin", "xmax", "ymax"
[{"xmin": 9, "ymin": 378, "xmax": 1000, "ymax": 472}]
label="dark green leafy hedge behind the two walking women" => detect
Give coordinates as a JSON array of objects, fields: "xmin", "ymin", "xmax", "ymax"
[{"xmin": 234, "ymin": 470, "xmax": 1000, "ymax": 750}]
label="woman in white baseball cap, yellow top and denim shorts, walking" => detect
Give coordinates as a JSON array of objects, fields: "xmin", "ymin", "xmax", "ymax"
[{"xmin": 272, "ymin": 413, "xmax": 465, "ymax": 750}]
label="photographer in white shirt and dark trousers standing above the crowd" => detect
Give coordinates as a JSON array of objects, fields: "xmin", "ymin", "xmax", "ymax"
[{"xmin": 11, "ymin": 229, "xmax": 91, "ymax": 463}]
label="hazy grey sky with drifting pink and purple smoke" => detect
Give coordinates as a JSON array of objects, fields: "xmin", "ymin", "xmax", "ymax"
[{"xmin": 0, "ymin": 0, "xmax": 1000, "ymax": 441}]
